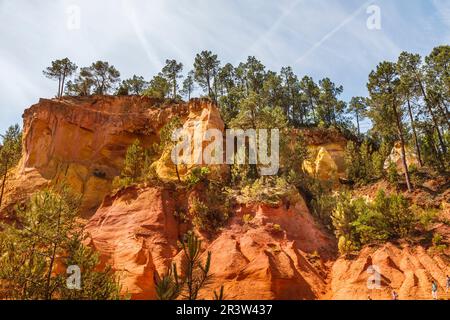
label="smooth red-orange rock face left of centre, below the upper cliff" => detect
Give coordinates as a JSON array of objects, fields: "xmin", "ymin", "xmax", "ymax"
[{"xmin": 86, "ymin": 188, "xmax": 179, "ymax": 299}]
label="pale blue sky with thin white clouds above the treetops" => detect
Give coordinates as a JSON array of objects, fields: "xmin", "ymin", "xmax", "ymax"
[{"xmin": 0, "ymin": 0, "xmax": 450, "ymax": 132}]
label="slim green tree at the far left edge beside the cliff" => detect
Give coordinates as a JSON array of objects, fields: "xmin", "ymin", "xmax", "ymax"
[{"xmin": 0, "ymin": 124, "xmax": 22, "ymax": 206}]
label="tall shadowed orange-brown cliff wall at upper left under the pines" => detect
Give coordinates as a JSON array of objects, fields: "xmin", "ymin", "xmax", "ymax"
[{"xmin": 4, "ymin": 96, "xmax": 216, "ymax": 217}]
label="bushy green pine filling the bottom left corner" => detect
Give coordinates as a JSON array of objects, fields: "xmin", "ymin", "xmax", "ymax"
[{"xmin": 0, "ymin": 187, "xmax": 119, "ymax": 300}]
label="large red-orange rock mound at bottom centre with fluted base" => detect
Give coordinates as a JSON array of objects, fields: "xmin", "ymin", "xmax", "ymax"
[{"xmin": 204, "ymin": 205, "xmax": 334, "ymax": 300}]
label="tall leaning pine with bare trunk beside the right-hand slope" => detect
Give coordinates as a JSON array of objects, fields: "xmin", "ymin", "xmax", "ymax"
[{"xmin": 367, "ymin": 61, "xmax": 412, "ymax": 192}]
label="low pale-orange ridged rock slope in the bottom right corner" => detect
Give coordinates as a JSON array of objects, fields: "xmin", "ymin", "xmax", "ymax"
[{"xmin": 327, "ymin": 244, "xmax": 450, "ymax": 300}]
